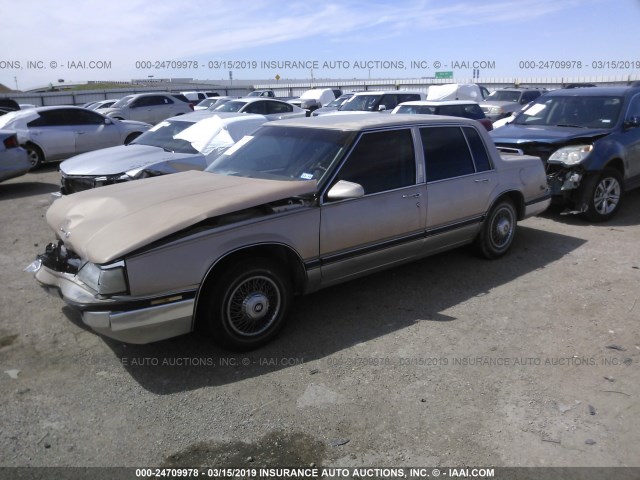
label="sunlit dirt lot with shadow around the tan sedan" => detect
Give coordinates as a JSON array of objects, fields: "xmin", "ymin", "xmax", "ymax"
[{"xmin": 0, "ymin": 167, "xmax": 640, "ymax": 467}]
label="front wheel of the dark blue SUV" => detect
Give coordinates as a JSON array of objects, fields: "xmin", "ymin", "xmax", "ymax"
[{"xmin": 583, "ymin": 168, "xmax": 623, "ymax": 222}]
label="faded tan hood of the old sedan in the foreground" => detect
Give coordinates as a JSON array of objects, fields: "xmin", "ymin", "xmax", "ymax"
[{"xmin": 46, "ymin": 171, "xmax": 316, "ymax": 264}]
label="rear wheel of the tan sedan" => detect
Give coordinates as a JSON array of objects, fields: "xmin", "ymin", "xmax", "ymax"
[{"xmin": 476, "ymin": 198, "xmax": 518, "ymax": 259}]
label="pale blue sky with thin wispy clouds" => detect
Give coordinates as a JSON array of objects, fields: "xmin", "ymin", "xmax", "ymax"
[{"xmin": 0, "ymin": 0, "xmax": 640, "ymax": 90}]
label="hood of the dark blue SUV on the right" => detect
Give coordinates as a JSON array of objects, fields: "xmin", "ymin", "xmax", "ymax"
[{"xmin": 489, "ymin": 123, "xmax": 611, "ymax": 145}]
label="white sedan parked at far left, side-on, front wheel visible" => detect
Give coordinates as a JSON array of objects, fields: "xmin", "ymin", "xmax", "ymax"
[{"xmin": 0, "ymin": 107, "xmax": 151, "ymax": 167}]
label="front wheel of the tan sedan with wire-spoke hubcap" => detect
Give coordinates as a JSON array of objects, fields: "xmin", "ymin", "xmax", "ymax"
[{"xmin": 199, "ymin": 258, "xmax": 292, "ymax": 351}]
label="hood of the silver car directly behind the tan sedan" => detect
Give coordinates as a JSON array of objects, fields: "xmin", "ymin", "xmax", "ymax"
[{"xmin": 60, "ymin": 144, "xmax": 206, "ymax": 176}]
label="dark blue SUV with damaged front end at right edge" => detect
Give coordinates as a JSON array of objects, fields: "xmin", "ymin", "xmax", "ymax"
[{"xmin": 491, "ymin": 87, "xmax": 640, "ymax": 222}]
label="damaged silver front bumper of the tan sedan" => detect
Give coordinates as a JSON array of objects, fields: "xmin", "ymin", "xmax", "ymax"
[{"xmin": 25, "ymin": 253, "xmax": 195, "ymax": 344}]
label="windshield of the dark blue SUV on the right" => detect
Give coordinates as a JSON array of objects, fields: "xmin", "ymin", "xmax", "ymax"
[{"xmin": 513, "ymin": 95, "xmax": 622, "ymax": 128}]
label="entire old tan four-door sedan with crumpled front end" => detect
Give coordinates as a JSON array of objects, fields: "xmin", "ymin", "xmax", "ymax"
[{"xmin": 28, "ymin": 114, "xmax": 549, "ymax": 350}]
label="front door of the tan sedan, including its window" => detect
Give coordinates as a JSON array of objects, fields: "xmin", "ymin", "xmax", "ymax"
[{"xmin": 320, "ymin": 128, "xmax": 426, "ymax": 285}]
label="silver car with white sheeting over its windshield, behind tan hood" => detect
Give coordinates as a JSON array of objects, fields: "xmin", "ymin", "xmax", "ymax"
[{"xmin": 60, "ymin": 110, "xmax": 267, "ymax": 194}]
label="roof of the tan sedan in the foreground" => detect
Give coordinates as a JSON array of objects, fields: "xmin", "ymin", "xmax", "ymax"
[{"xmin": 267, "ymin": 112, "xmax": 478, "ymax": 131}]
